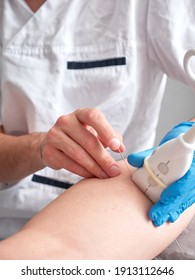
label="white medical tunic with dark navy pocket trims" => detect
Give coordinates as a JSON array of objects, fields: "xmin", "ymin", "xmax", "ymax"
[{"xmin": 0, "ymin": 0, "xmax": 195, "ymax": 252}]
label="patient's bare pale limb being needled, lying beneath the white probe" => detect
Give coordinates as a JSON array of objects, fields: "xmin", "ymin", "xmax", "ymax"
[{"xmin": 0, "ymin": 161, "xmax": 195, "ymax": 260}]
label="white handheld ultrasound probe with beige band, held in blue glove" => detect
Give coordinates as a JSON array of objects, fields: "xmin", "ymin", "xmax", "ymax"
[{"xmin": 132, "ymin": 125, "xmax": 195, "ymax": 203}]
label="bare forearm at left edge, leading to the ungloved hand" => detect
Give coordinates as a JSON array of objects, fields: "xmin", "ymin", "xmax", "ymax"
[{"xmin": 0, "ymin": 130, "xmax": 44, "ymax": 183}]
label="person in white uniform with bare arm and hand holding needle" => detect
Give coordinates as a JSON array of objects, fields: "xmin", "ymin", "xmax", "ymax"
[{"xmin": 0, "ymin": 0, "xmax": 195, "ymax": 245}]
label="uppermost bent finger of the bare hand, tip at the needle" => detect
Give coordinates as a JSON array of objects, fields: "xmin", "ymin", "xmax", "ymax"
[{"xmin": 76, "ymin": 108, "xmax": 124, "ymax": 151}]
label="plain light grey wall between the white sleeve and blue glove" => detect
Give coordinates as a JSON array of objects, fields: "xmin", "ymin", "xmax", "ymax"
[{"xmin": 155, "ymin": 79, "xmax": 195, "ymax": 145}]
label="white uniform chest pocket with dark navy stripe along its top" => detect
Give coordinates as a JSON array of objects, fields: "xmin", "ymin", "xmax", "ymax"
[{"xmin": 61, "ymin": 43, "xmax": 131, "ymax": 110}]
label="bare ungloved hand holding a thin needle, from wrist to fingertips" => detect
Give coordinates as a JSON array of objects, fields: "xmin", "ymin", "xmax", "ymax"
[{"xmin": 41, "ymin": 108, "xmax": 125, "ymax": 178}]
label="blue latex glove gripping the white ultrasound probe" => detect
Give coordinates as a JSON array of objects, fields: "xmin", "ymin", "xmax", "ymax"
[{"xmin": 128, "ymin": 122, "xmax": 195, "ymax": 226}]
